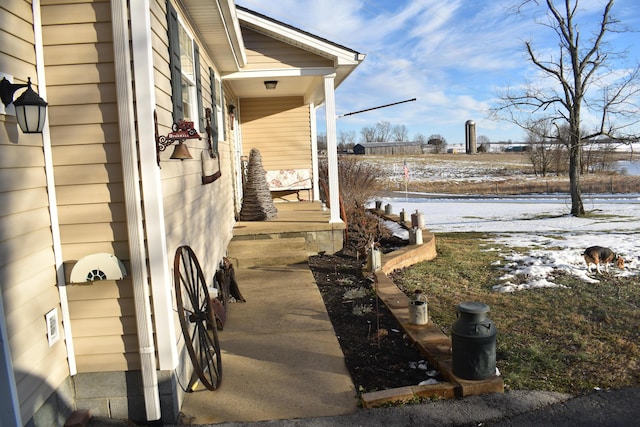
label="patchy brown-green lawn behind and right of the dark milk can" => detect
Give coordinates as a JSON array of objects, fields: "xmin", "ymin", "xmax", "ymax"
[{"xmin": 394, "ymin": 233, "xmax": 640, "ymax": 393}]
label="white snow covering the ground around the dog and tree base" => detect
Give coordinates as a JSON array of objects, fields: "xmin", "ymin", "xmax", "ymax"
[{"xmin": 380, "ymin": 193, "xmax": 640, "ymax": 292}]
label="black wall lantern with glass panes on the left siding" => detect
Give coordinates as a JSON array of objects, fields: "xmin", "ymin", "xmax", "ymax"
[{"xmin": 0, "ymin": 77, "xmax": 47, "ymax": 133}]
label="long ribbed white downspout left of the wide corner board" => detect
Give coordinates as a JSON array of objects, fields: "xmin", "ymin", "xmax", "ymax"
[{"xmin": 111, "ymin": 0, "xmax": 162, "ymax": 421}]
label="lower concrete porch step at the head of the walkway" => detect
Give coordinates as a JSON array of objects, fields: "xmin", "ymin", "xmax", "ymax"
[{"xmin": 227, "ymin": 235, "xmax": 310, "ymax": 268}]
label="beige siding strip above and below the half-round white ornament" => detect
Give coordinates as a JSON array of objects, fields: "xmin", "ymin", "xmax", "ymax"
[{"xmin": 42, "ymin": 0, "xmax": 139, "ymax": 372}]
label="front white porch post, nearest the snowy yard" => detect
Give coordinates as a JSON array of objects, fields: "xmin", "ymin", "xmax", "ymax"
[{"xmin": 324, "ymin": 74, "xmax": 342, "ymax": 223}]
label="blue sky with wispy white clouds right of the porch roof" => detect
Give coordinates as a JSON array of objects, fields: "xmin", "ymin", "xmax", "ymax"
[{"xmin": 238, "ymin": 0, "xmax": 640, "ymax": 144}]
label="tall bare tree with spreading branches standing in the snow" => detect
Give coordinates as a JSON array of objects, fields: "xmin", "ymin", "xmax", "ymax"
[{"xmin": 493, "ymin": 0, "xmax": 640, "ymax": 216}]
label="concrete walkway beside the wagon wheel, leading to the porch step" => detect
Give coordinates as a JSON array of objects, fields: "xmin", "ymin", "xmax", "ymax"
[{"xmin": 182, "ymin": 263, "xmax": 358, "ymax": 425}]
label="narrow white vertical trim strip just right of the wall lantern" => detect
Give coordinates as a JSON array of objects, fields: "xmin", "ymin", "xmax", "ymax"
[{"xmin": 32, "ymin": 0, "xmax": 78, "ymax": 376}]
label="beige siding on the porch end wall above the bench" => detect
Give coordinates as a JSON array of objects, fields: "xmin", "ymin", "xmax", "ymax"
[{"xmin": 240, "ymin": 97, "xmax": 312, "ymax": 171}]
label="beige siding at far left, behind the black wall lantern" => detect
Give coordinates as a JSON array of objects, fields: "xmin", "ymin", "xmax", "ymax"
[{"xmin": 0, "ymin": 0, "xmax": 69, "ymax": 422}]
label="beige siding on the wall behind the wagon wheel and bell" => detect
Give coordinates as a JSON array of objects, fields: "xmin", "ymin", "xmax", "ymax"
[{"xmin": 151, "ymin": 1, "xmax": 238, "ymax": 380}]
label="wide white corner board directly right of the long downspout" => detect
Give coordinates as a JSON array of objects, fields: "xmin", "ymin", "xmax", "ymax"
[{"xmin": 127, "ymin": 0, "xmax": 179, "ymax": 371}]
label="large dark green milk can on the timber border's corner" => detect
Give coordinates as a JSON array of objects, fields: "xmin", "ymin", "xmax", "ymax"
[{"xmin": 451, "ymin": 302, "xmax": 497, "ymax": 380}]
